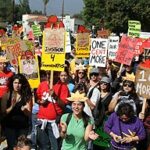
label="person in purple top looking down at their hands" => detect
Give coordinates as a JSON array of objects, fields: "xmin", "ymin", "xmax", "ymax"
[{"xmin": 104, "ymin": 103, "xmax": 146, "ymax": 150}]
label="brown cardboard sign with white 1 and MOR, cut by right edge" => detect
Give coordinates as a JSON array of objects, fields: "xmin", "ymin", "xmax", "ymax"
[{"xmin": 136, "ymin": 66, "xmax": 150, "ymax": 98}]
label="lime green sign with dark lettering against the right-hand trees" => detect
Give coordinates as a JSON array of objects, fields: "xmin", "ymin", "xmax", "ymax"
[{"xmin": 128, "ymin": 20, "xmax": 141, "ymax": 37}]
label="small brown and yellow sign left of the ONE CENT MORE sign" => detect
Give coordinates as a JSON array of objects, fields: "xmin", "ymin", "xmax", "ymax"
[{"xmin": 76, "ymin": 33, "xmax": 90, "ymax": 58}]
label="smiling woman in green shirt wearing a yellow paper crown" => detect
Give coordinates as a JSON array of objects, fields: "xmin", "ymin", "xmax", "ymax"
[{"xmin": 60, "ymin": 91, "xmax": 98, "ymax": 150}]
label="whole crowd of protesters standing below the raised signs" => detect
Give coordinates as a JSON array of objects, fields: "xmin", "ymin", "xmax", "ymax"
[{"xmin": 0, "ymin": 19, "xmax": 150, "ymax": 150}]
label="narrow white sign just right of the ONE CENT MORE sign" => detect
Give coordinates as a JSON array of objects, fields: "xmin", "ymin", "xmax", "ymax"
[{"xmin": 108, "ymin": 36, "xmax": 119, "ymax": 60}]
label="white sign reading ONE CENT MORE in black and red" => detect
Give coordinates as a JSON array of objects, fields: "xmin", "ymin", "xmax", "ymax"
[{"xmin": 89, "ymin": 38, "xmax": 108, "ymax": 67}]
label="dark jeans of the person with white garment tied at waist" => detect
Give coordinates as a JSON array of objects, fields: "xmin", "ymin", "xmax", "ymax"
[{"xmin": 37, "ymin": 122, "xmax": 58, "ymax": 150}]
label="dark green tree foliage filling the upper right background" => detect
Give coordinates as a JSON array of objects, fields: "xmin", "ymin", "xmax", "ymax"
[{"xmin": 82, "ymin": 0, "xmax": 150, "ymax": 33}]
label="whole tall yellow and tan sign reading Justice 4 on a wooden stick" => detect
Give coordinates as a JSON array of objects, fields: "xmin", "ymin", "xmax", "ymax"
[{"xmin": 41, "ymin": 29, "xmax": 65, "ymax": 71}]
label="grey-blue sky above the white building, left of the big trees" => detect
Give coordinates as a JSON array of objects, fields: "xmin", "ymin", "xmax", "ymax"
[{"xmin": 16, "ymin": 0, "xmax": 84, "ymax": 15}]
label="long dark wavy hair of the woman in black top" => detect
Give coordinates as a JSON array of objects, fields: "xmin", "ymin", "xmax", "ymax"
[{"xmin": 8, "ymin": 74, "xmax": 32, "ymax": 102}]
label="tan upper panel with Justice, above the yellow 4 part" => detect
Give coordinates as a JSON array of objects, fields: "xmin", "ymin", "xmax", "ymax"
[{"xmin": 43, "ymin": 28, "xmax": 65, "ymax": 54}]
